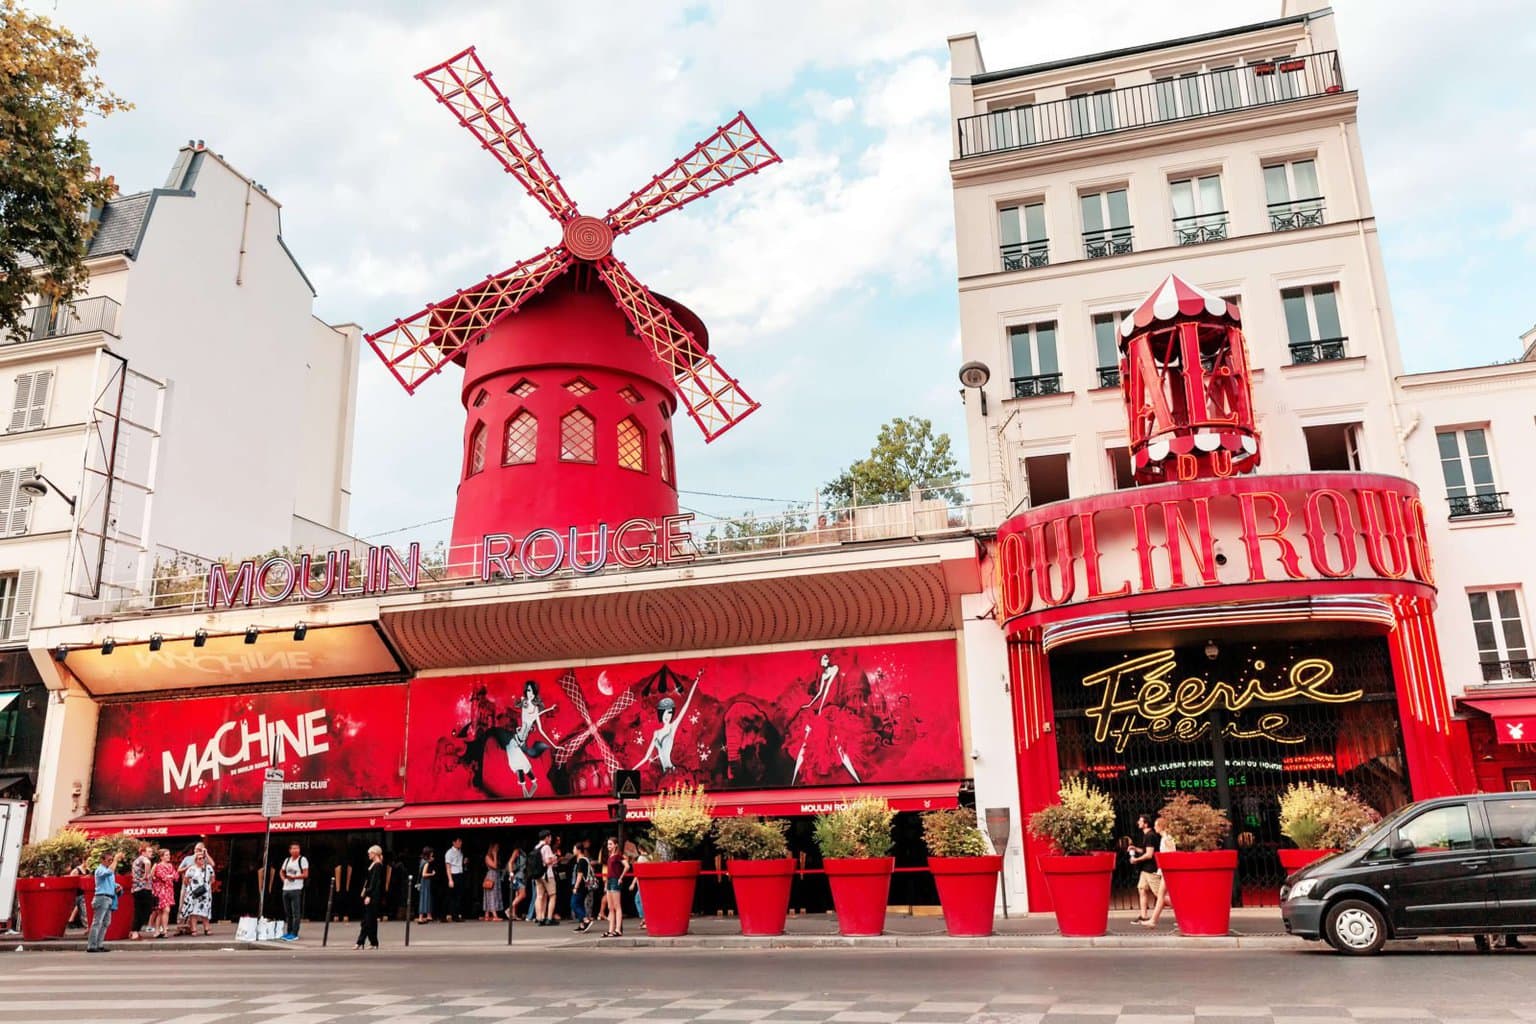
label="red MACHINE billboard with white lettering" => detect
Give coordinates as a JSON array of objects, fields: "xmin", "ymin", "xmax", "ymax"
[{"xmin": 91, "ymin": 685, "xmax": 406, "ymax": 814}]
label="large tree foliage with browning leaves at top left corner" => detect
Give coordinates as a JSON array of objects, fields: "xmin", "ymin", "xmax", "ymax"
[{"xmin": 0, "ymin": 0, "xmax": 129, "ymax": 332}]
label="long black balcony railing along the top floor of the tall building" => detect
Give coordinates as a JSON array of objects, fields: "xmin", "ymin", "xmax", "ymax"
[{"xmin": 957, "ymin": 51, "xmax": 1344, "ymax": 158}]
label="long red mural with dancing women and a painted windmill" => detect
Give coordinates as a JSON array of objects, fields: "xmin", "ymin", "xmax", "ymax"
[{"xmin": 406, "ymin": 640, "xmax": 965, "ymax": 803}]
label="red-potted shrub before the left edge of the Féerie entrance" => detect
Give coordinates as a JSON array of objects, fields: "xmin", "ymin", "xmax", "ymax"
[{"xmin": 1029, "ymin": 778, "xmax": 1115, "ymax": 935}]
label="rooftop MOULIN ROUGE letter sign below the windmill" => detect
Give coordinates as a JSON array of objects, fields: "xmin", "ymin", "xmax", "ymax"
[{"xmin": 207, "ymin": 513, "xmax": 694, "ymax": 608}]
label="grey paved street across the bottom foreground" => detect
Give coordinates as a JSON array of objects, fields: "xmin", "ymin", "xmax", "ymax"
[{"xmin": 0, "ymin": 944, "xmax": 1536, "ymax": 1024}]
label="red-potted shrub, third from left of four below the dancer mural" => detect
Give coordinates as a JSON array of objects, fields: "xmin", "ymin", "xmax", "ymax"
[{"xmin": 814, "ymin": 797, "xmax": 895, "ymax": 935}]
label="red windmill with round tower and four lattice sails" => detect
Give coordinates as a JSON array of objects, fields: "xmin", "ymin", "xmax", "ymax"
[{"xmin": 367, "ymin": 46, "xmax": 779, "ymax": 574}]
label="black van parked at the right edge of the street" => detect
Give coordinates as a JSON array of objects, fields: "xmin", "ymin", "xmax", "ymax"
[{"xmin": 1279, "ymin": 792, "xmax": 1536, "ymax": 956}]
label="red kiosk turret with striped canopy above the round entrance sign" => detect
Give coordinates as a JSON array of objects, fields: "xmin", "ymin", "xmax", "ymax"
[{"xmin": 1120, "ymin": 275, "xmax": 1260, "ymax": 484}]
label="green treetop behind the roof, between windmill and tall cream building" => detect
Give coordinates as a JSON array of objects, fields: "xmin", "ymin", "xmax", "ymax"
[{"xmin": 822, "ymin": 416, "xmax": 963, "ymax": 508}]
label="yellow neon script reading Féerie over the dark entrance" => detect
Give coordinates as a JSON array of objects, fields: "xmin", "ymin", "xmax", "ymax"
[{"xmin": 1083, "ymin": 651, "xmax": 1364, "ymax": 752}]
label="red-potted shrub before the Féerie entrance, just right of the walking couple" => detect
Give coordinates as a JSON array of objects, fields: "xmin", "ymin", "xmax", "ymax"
[{"xmin": 1157, "ymin": 792, "xmax": 1238, "ymax": 935}]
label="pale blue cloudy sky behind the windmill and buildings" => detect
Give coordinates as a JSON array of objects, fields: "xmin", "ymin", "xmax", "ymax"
[{"xmin": 32, "ymin": 0, "xmax": 1536, "ymax": 540}]
